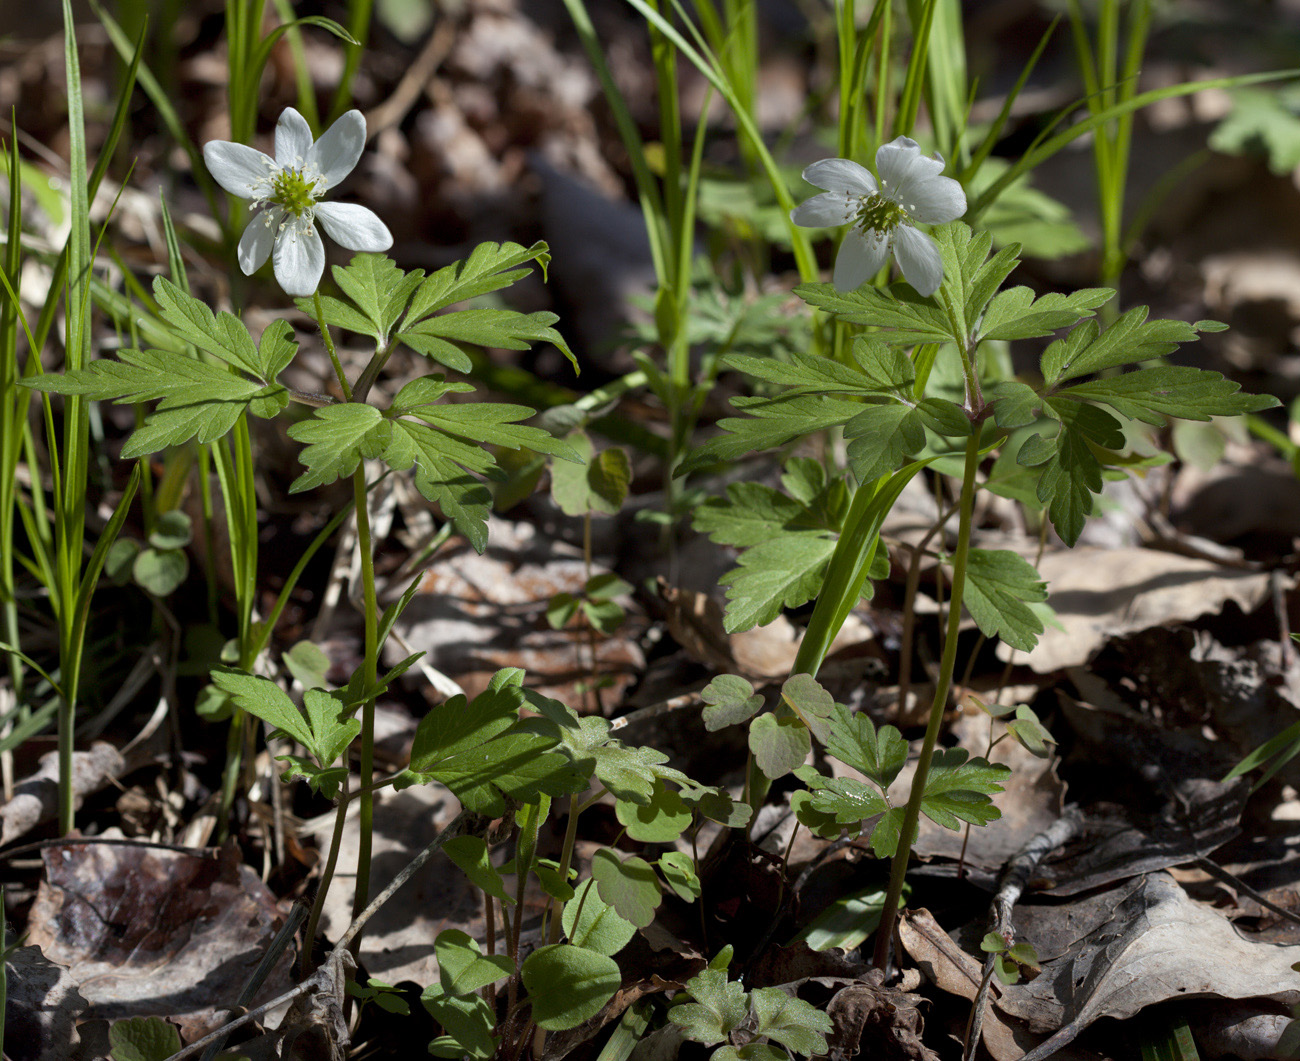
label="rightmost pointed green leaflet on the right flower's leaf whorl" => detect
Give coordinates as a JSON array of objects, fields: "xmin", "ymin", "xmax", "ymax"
[{"xmin": 1057, "ymin": 365, "xmax": 1279, "ymax": 426}]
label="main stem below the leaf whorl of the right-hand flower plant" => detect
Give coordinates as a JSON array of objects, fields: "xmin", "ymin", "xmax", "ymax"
[{"xmin": 874, "ymin": 424, "xmax": 982, "ymax": 969}]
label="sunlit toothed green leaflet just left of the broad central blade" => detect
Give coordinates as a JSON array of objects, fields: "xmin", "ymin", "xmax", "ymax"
[{"xmin": 719, "ymin": 532, "xmax": 835, "ymax": 633}]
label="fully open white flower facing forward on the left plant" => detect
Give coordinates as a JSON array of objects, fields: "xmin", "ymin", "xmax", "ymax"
[{"xmin": 203, "ymin": 107, "xmax": 393, "ymax": 295}]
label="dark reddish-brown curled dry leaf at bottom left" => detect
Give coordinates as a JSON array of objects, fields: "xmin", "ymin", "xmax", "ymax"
[{"xmin": 29, "ymin": 844, "xmax": 293, "ymax": 1040}]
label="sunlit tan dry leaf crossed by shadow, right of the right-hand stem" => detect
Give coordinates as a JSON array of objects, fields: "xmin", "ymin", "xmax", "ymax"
[{"xmin": 997, "ymin": 547, "xmax": 1269, "ymax": 674}]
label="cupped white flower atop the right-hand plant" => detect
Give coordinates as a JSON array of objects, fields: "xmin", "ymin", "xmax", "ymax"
[{"xmin": 790, "ymin": 137, "xmax": 966, "ymax": 296}]
